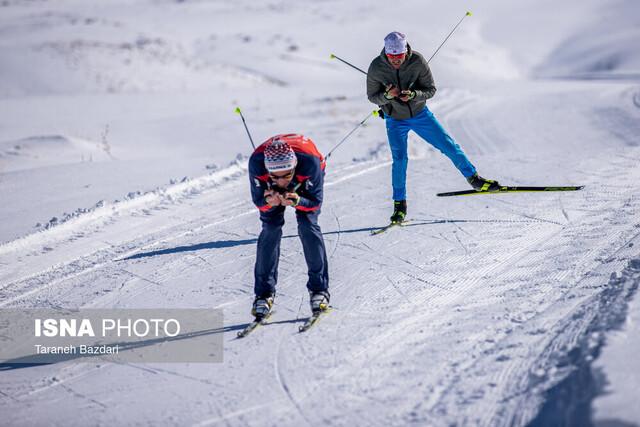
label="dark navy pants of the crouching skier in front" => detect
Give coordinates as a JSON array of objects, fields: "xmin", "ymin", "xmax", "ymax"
[{"xmin": 254, "ymin": 206, "xmax": 329, "ymax": 296}]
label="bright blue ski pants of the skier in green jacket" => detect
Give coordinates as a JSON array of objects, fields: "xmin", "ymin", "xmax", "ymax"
[{"xmin": 385, "ymin": 107, "xmax": 476, "ymax": 200}]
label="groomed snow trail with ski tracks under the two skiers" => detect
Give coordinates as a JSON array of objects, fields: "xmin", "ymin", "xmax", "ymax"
[{"xmin": 0, "ymin": 82, "xmax": 640, "ymax": 426}]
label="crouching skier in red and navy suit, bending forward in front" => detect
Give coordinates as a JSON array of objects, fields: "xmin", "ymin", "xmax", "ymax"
[{"xmin": 249, "ymin": 134, "xmax": 330, "ymax": 319}]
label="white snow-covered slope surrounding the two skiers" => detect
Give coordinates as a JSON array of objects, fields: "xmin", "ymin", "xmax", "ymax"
[{"xmin": 0, "ymin": 0, "xmax": 640, "ymax": 426}]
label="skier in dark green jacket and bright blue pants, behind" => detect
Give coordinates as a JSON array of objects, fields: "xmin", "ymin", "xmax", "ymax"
[{"xmin": 367, "ymin": 31, "xmax": 500, "ymax": 223}]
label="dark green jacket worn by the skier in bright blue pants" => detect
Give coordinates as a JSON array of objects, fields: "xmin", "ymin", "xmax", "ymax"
[{"xmin": 367, "ymin": 46, "xmax": 436, "ymax": 120}]
